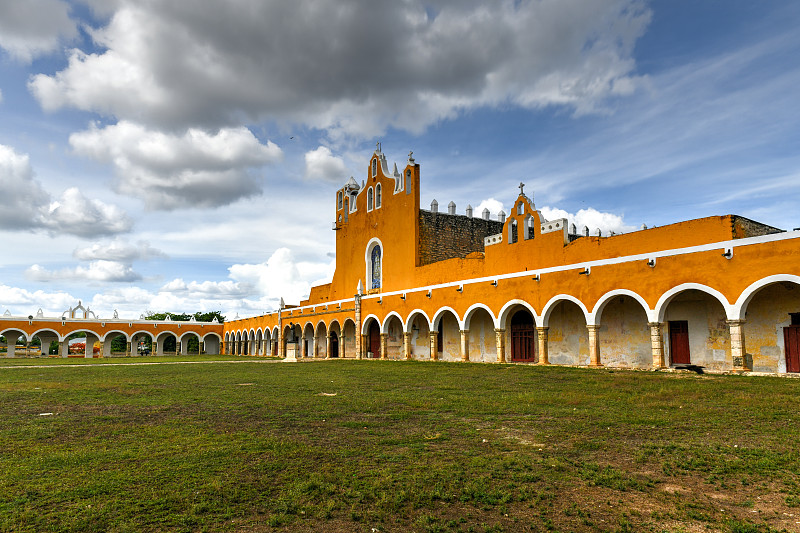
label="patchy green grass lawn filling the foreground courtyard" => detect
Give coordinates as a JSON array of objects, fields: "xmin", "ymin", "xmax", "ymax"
[{"xmin": 0, "ymin": 356, "xmax": 800, "ymax": 533}]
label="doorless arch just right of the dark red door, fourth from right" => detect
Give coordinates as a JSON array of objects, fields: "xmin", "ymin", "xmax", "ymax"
[{"xmin": 541, "ymin": 294, "xmax": 590, "ymax": 366}]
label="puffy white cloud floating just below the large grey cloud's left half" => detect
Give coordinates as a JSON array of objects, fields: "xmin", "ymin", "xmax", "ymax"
[{"xmin": 69, "ymin": 121, "xmax": 283, "ymax": 210}]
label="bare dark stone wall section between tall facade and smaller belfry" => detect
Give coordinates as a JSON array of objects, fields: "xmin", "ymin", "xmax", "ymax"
[{"xmin": 419, "ymin": 210, "xmax": 503, "ymax": 265}]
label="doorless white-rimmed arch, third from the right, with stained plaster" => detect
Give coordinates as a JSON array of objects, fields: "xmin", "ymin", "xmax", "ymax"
[{"xmin": 591, "ymin": 289, "xmax": 654, "ymax": 368}]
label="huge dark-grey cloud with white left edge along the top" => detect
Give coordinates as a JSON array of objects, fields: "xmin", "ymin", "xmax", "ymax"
[{"xmin": 30, "ymin": 0, "xmax": 651, "ymax": 138}]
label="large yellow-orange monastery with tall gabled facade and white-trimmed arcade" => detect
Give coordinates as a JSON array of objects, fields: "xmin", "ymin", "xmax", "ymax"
[{"xmin": 223, "ymin": 143, "xmax": 800, "ymax": 373}]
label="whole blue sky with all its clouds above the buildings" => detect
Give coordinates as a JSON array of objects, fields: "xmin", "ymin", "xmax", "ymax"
[{"xmin": 0, "ymin": 0, "xmax": 800, "ymax": 318}]
